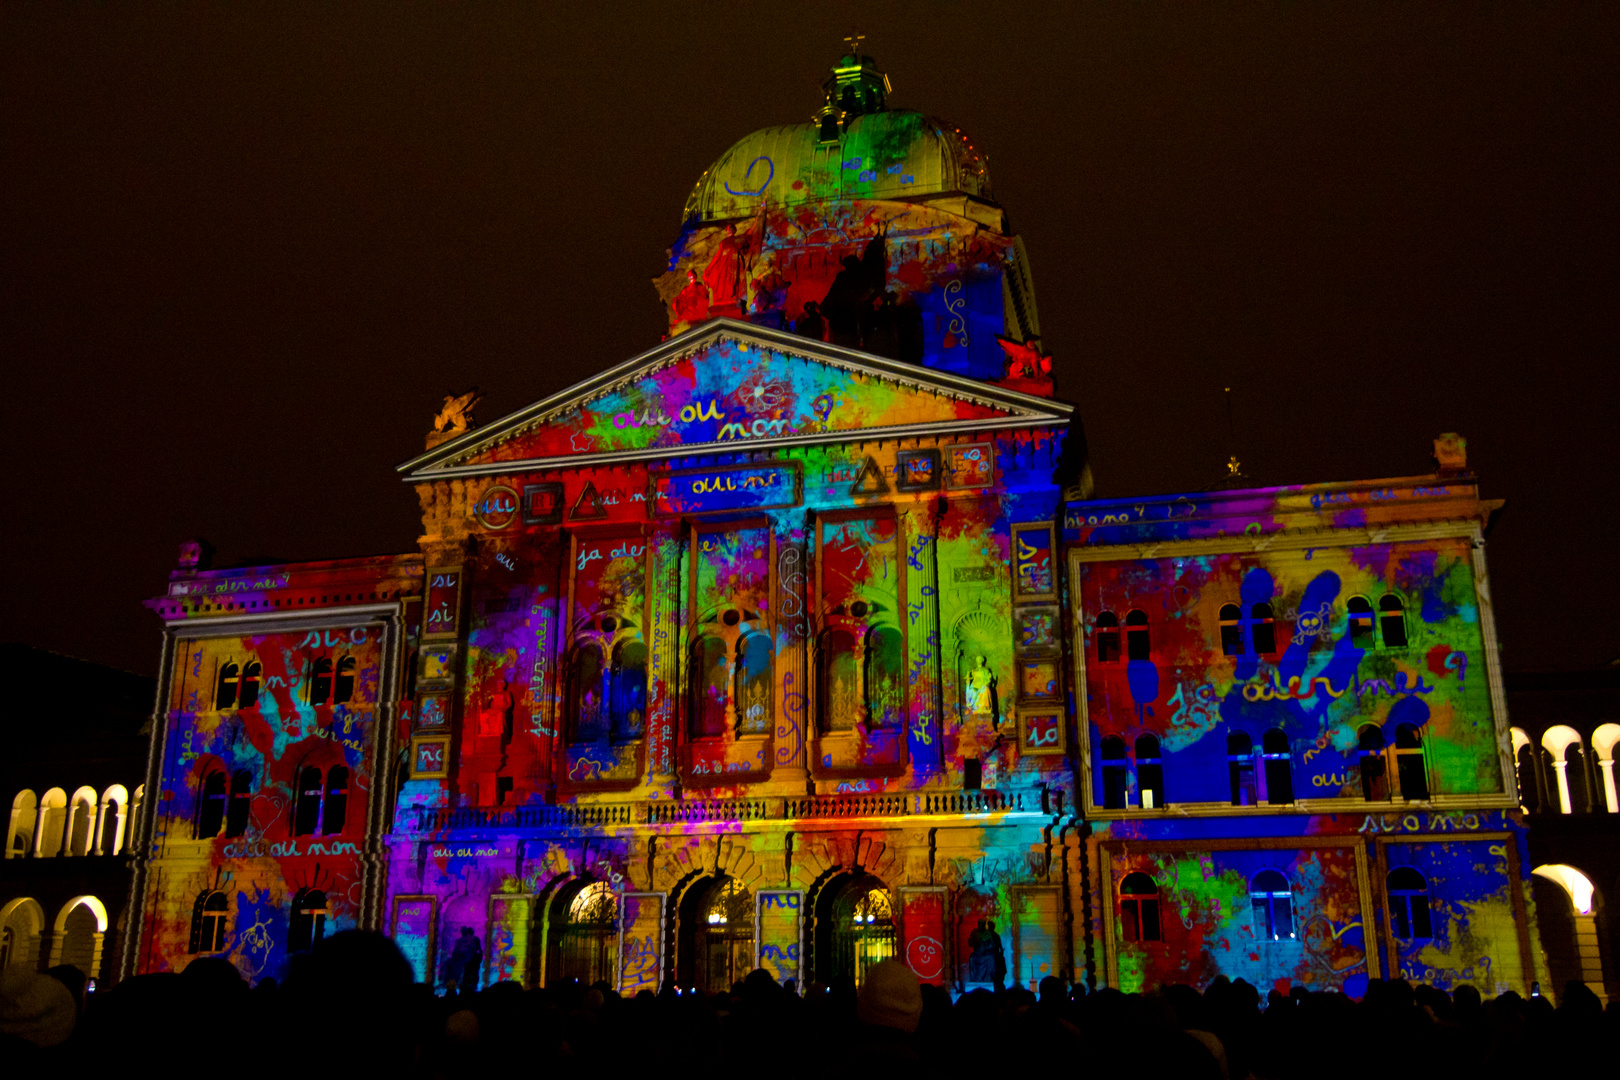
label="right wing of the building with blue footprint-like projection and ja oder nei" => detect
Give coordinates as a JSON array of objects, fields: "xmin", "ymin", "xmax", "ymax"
[{"xmin": 1068, "ymin": 476, "xmax": 1542, "ymax": 994}]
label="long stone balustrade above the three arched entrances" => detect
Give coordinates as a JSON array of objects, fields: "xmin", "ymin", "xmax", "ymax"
[{"xmin": 407, "ymin": 790, "xmax": 1043, "ymax": 832}]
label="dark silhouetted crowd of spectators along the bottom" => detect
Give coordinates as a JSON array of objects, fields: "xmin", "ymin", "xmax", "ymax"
[{"xmin": 0, "ymin": 931, "xmax": 1620, "ymax": 1080}]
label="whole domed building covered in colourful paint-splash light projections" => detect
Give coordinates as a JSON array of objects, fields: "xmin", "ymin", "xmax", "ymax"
[{"xmin": 130, "ymin": 57, "xmax": 1533, "ymax": 993}]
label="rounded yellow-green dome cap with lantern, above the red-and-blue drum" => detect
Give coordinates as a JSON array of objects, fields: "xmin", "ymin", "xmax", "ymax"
[{"xmin": 684, "ymin": 55, "xmax": 1000, "ymax": 225}]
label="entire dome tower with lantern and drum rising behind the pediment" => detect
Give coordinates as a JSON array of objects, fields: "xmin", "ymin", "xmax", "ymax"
[{"xmin": 658, "ymin": 55, "xmax": 1050, "ymax": 392}]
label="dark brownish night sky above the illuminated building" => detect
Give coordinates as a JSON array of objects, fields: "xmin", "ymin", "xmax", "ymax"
[{"xmin": 0, "ymin": 0, "xmax": 1620, "ymax": 672}]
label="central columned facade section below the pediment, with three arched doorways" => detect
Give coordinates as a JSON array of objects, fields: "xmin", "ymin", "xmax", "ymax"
[{"xmin": 389, "ymin": 408, "xmax": 1081, "ymax": 989}]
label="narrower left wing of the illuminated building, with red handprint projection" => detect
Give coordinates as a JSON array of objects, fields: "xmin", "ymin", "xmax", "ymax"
[{"xmin": 130, "ymin": 559, "xmax": 420, "ymax": 978}]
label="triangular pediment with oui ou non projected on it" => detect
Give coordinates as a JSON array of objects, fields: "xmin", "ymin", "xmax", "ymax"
[{"xmin": 399, "ymin": 319, "xmax": 1074, "ymax": 479}]
